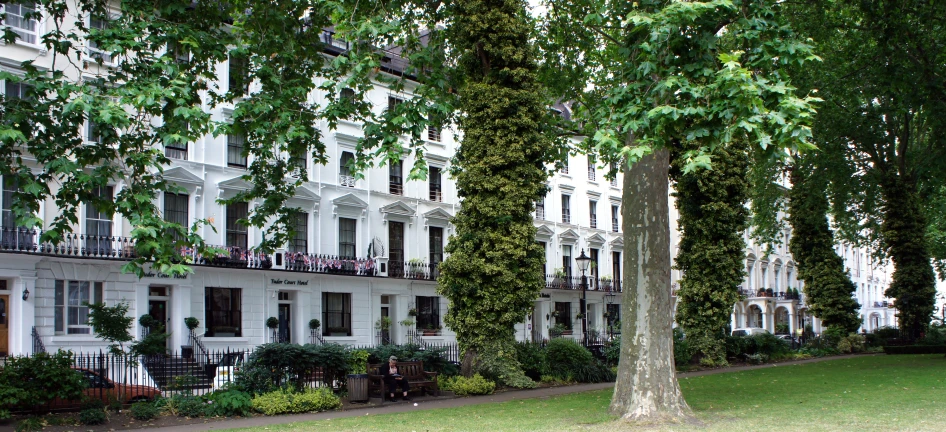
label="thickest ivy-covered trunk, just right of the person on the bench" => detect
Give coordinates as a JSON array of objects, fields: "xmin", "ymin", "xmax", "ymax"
[{"xmin": 438, "ymin": 0, "xmax": 551, "ymax": 375}]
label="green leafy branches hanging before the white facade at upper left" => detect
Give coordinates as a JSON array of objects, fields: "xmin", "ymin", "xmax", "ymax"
[{"xmin": 0, "ymin": 0, "xmax": 426, "ymax": 275}]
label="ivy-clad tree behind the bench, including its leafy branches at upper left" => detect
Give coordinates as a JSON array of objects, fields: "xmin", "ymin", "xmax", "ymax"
[{"xmin": 336, "ymin": 0, "xmax": 564, "ymax": 385}]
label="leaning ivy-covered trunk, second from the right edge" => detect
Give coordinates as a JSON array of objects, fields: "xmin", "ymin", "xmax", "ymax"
[{"xmin": 788, "ymin": 160, "xmax": 861, "ymax": 332}]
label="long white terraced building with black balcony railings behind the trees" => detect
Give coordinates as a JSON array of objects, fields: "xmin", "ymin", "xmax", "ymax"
[{"xmin": 0, "ymin": 0, "xmax": 893, "ymax": 356}]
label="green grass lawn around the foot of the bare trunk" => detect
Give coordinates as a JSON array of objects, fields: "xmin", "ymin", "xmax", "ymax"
[{"xmin": 227, "ymin": 355, "xmax": 946, "ymax": 432}]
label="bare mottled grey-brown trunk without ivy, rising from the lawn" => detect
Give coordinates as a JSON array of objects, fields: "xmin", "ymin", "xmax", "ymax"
[{"xmin": 611, "ymin": 150, "xmax": 690, "ymax": 420}]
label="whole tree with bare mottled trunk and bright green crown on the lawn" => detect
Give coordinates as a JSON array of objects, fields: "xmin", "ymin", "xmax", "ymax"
[{"xmin": 544, "ymin": 0, "xmax": 813, "ymax": 419}]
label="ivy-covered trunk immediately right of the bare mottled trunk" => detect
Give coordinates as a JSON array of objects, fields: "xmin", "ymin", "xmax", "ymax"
[{"xmin": 673, "ymin": 142, "xmax": 749, "ymax": 366}]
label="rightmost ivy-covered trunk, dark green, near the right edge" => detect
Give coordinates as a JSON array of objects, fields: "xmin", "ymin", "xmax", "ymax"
[{"xmin": 881, "ymin": 174, "xmax": 936, "ymax": 339}]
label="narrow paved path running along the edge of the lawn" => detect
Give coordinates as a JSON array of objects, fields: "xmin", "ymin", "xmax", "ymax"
[{"xmin": 151, "ymin": 354, "xmax": 864, "ymax": 432}]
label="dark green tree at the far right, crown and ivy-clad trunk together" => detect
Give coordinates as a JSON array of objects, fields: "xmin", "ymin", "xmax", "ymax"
[{"xmin": 787, "ymin": 0, "xmax": 946, "ymax": 338}]
